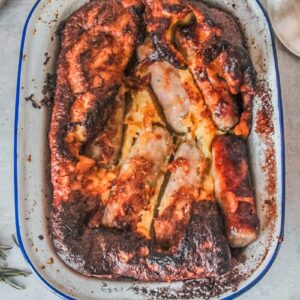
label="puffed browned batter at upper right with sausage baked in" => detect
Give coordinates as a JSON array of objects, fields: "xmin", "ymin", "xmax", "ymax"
[{"xmin": 145, "ymin": 0, "xmax": 254, "ymax": 137}]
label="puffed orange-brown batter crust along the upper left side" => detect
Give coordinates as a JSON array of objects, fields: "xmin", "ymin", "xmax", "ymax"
[{"xmin": 49, "ymin": 0, "xmax": 141, "ymax": 205}]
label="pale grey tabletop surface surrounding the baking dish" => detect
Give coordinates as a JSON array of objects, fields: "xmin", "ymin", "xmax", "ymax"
[{"xmin": 0, "ymin": 0, "xmax": 300, "ymax": 300}]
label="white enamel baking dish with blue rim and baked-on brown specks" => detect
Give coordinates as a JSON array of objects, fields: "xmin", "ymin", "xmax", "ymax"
[{"xmin": 14, "ymin": 0, "xmax": 285, "ymax": 299}]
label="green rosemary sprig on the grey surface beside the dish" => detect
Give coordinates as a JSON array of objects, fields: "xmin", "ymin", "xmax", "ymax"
[{"xmin": 0, "ymin": 239, "xmax": 30, "ymax": 290}]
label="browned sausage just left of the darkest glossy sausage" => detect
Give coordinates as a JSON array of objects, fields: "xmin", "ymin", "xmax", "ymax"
[{"xmin": 154, "ymin": 142, "xmax": 204, "ymax": 248}]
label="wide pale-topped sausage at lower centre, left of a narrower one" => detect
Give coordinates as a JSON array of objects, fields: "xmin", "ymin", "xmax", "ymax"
[{"xmin": 102, "ymin": 127, "xmax": 172, "ymax": 230}]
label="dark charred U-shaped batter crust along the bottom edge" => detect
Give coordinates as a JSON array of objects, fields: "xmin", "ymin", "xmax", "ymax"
[{"xmin": 51, "ymin": 199, "xmax": 230, "ymax": 281}]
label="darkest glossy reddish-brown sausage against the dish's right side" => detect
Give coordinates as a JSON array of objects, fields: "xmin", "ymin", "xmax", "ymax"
[{"xmin": 212, "ymin": 135, "xmax": 259, "ymax": 247}]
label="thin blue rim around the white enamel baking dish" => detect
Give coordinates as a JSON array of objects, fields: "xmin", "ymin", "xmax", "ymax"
[{"xmin": 14, "ymin": 0, "xmax": 285, "ymax": 300}]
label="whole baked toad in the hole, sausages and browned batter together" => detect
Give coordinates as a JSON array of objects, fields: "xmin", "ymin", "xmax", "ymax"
[{"xmin": 49, "ymin": 0, "xmax": 258, "ymax": 281}]
